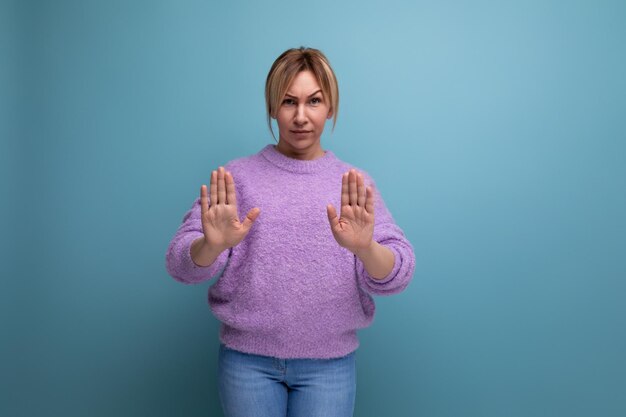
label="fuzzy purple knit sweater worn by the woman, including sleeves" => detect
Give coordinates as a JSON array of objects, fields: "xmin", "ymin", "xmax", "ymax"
[{"xmin": 166, "ymin": 144, "xmax": 415, "ymax": 359}]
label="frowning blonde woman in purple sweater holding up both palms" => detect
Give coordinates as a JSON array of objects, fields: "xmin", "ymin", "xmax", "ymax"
[{"xmin": 166, "ymin": 47, "xmax": 415, "ymax": 417}]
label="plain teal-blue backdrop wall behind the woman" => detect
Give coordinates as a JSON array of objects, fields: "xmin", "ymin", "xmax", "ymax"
[{"xmin": 0, "ymin": 0, "xmax": 626, "ymax": 417}]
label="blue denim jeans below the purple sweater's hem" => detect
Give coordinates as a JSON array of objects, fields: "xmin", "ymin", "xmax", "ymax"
[{"xmin": 218, "ymin": 343, "xmax": 356, "ymax": 417}]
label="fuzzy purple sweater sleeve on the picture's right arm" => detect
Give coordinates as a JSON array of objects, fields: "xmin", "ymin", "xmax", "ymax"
[{"xmin": 354, "ymin": 171, "xmax": 415, "ymax": 295}]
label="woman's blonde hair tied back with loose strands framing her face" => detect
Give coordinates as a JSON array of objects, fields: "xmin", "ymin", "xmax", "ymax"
[{"xmin": 265, "ymin": 46, "xmax": 339, "ymax": 140}]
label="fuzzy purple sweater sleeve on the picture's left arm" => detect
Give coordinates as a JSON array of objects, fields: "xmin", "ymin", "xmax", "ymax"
[{"xmin": 165, "ymin": 197, "xmax": 232, "ymax": 284}]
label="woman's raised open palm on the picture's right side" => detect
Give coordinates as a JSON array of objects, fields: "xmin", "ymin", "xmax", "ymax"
[{"xmin": 326, "ymin": 169, "xmax": 374, "ymax": 254}]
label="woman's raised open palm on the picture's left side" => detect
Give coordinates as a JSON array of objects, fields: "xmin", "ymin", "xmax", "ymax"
[{"xmin": 200, "ymin": 167, "xmax": 261, "ymax": 250}]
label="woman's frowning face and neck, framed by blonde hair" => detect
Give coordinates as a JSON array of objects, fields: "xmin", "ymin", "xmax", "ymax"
[{"xmin": 276, "ymin": 71, "xmax": 333, "ymax": 159}]
